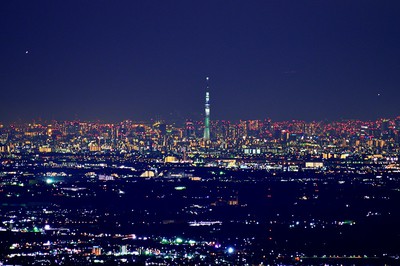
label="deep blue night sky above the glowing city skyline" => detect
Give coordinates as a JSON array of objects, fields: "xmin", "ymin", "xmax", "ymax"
[{"xmin": 0, "ymin": 0, "xmax": 400, "ymax": 122}]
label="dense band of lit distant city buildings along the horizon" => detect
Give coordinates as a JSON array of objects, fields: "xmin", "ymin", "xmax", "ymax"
[{"xmin": 0, "ymin": 116, "xmax": 400, "ymax": 166}]
